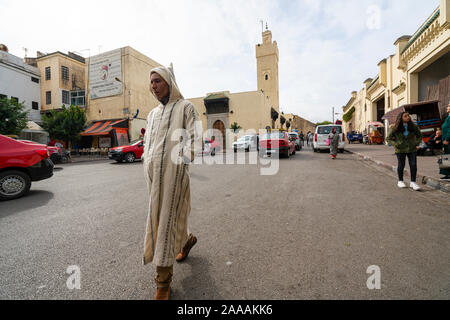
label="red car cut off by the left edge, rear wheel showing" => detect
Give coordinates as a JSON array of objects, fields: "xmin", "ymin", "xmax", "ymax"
[{"xmin": 0, "ymin": 135, "xmax": 53, "ymax": 200}]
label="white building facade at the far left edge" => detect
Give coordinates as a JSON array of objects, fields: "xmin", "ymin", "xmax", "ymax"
[{"xmin": 0, "ymin": 51, "xmax": 42, "ymax": 124}]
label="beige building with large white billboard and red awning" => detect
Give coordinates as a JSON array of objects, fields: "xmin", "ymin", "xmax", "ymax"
[{"xmin": 82, "ymin": 47, "xmax": 161, "ymax": 148}]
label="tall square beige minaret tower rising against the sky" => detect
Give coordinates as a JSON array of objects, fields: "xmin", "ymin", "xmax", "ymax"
[{"xmin": 256, "ymin": 25, "xmax": 280, "ymax": 113}]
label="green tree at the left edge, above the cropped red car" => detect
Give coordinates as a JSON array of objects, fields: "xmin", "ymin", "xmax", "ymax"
[{"xmin": 0, "ymin": 98, "xmax": 28, "ymax": 135}]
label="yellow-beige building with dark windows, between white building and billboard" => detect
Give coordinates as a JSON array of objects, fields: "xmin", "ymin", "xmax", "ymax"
[{"xmin": 33, "ymin": 51, "xmax": 86, "ymax": 113}]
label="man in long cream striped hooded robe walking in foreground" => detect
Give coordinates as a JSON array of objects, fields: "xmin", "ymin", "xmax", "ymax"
[{"xmin": 143, "ymin": 67, "xmax": 203, "ymax": 300}]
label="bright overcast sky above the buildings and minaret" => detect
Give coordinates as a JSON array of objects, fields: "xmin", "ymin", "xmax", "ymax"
[{"xmin": 0, "ymin": 0, "xmax": 439, "ymax": 122}]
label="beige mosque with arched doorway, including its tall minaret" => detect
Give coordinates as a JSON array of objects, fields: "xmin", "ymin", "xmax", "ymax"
[{"xmin": 189, "ymin": 30, "xmax": 280, "ymax": 148}]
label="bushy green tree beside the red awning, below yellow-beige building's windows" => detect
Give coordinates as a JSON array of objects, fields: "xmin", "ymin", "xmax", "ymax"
[{"xmin": 42, "ymin": 105, "xmax": 86, "ymax": 148}]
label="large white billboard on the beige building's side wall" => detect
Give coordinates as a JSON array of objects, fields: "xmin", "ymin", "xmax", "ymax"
[{"xmin": 89, "ymin": 49, "xmax": 122, "ymax": 99}]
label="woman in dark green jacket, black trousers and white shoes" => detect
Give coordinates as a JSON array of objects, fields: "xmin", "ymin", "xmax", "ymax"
[{"xmin": 386, "ymin": 112, "xmax": 422, "ymax": 191}]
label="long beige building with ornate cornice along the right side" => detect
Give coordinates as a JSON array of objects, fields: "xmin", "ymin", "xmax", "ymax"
[{"xmin": 343, "ymin": 0, "xmax": 450, "ymax": 136}]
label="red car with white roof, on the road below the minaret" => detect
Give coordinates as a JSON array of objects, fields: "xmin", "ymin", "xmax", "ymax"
[{"xmin": 259, "ymin": 132, "xmax": 296, "ymax": 158}]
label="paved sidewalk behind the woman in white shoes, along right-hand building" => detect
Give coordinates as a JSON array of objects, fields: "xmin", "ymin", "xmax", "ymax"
[{"xmin": 345, "ymin": 143, "xmax": 450, "ymax": 192}]
